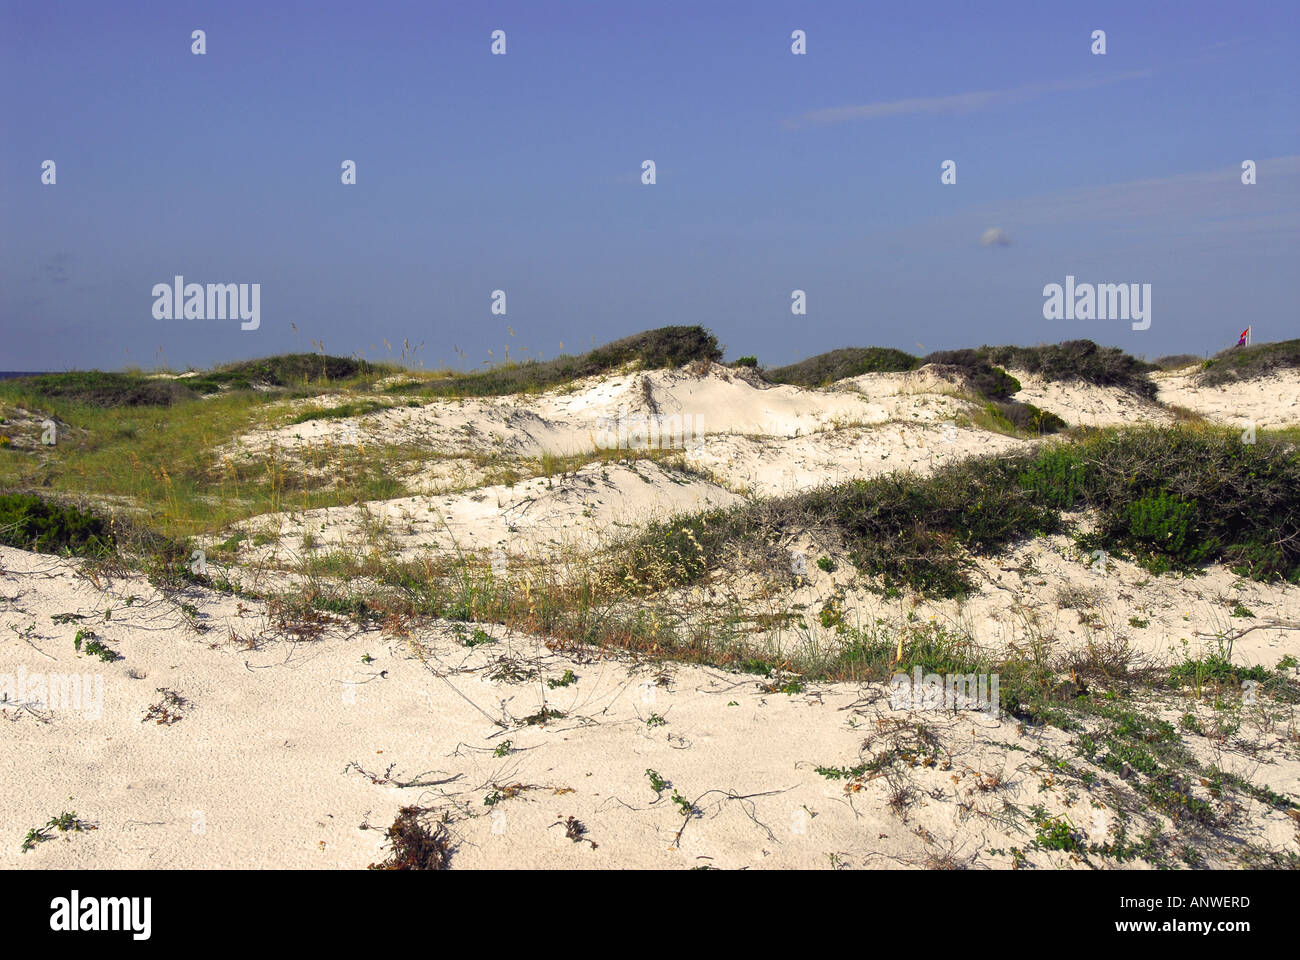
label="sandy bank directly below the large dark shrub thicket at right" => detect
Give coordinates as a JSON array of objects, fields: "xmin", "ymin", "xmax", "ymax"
[{"xmin": 727, "ymin": 518, "xmax": 1300, "ymax": 667}]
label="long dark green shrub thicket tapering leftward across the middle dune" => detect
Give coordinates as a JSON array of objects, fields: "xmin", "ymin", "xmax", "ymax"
[{"xmin": 623, "ymin": 427, "xmax": 1300, "ymax": 597}]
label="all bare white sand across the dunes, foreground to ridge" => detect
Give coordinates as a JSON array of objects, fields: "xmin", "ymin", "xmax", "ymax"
[{"xmin": 0, "ymin": 366, "xmax": 1300, "ymax": 869}]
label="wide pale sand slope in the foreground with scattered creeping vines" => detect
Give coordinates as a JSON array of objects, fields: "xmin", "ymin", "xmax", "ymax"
[{"xmin": 0, "ymin": 549, "xmax": 1300, "ymax": 868}]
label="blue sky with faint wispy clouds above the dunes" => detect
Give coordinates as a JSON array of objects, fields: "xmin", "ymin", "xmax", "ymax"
[{"xmin": 0, "ymin": 0, "xmax": 1300, "ymax": 369}]
